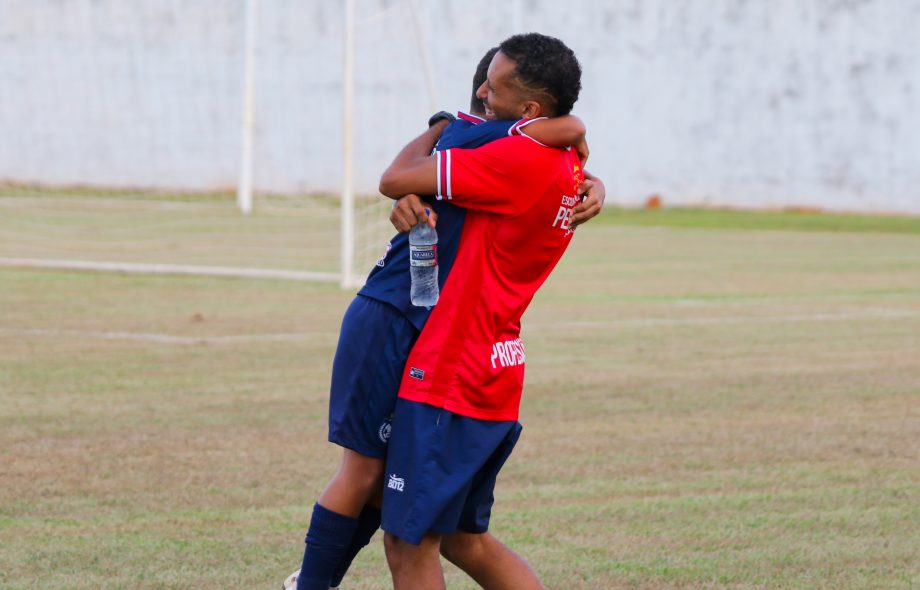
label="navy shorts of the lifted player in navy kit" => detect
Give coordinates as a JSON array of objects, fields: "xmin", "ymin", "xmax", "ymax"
[{"xmin": 329, "ymin": 295, "xmax": 418, "ymax": 459}]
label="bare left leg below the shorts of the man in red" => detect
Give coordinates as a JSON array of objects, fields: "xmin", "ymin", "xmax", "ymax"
[{"xmin": 383, "ymin": 533, "xmax": 446, "ymax": 590}]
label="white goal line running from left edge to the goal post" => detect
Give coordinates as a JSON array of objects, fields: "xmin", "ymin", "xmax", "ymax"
[{"xmin": 0, "ymin": 258, "xmax": 339, "ymax": 283}]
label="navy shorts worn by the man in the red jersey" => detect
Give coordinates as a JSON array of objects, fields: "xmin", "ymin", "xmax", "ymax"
[{"xmin": 381, "ymin": 399, "xmax": 521, "ymax": 545}]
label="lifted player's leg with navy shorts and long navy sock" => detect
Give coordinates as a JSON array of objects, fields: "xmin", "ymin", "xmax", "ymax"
[{"xmin": 297, "ymin": 296, "xmax": 416, "ymax": 590}]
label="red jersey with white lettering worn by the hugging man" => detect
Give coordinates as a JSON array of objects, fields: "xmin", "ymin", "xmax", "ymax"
[{"xmin": 399, "ymin": 135, "xmax": 584, "ymax": 420}]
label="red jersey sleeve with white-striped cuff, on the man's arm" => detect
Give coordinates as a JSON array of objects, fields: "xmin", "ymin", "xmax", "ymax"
[{"xmin": 435, "ymin": 136, "xmax": 558, "ymax": 215}]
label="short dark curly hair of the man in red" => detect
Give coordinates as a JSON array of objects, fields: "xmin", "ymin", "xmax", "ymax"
[{"xmin": 499, "ymin": 33, "xmax": 581, "ymax": 116}]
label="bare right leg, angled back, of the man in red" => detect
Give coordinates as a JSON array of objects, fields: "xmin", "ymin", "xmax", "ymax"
[{"xmin": 441, "ymin": 531, "xmax": 543, "ymax": 590}]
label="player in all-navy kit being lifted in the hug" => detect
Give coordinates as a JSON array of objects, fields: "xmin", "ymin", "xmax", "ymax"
[{"xmin": 285, "ymin": 48, "xmax": 604, "ymax": 590}]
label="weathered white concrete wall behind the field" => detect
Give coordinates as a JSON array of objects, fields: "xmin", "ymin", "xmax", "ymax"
[{"xmin": 0, "ymin": 0, "xmax": 920, "ymax": 213}]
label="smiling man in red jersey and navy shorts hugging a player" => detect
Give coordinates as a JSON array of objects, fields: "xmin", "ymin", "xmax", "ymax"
[{"xmin": 380, "ymin": 33, "xmax": 584, "ymax": 590}]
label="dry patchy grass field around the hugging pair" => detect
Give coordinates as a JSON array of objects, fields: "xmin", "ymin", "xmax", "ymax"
[{"xmin": 0, "ymin": 195, "xmax": 920, "ymax": 590}]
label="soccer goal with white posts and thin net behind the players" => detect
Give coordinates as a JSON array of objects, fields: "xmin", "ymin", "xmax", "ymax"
[{"xmin": 0, "ymin": 0, "xmax": 432, "ymax": 287}]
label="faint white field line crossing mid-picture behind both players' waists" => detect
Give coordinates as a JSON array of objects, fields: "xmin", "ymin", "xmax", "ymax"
[{"xmin": 0, "ymin": 309, "xmax": 920, "ymax": 345}]
